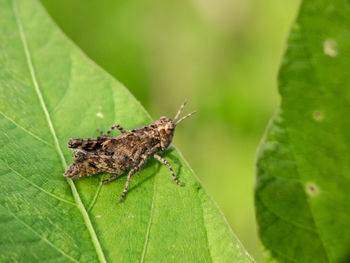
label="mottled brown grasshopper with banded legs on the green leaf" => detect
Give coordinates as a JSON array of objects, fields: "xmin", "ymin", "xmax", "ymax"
[{"xmin": 64, "ymin": 102, "xmax": 196, "ymax": 202}]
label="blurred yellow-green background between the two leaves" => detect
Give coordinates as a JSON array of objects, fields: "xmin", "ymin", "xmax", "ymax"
[{"xmin": 41, "ymin": 0, "xmax": 300, "ymax": 262}]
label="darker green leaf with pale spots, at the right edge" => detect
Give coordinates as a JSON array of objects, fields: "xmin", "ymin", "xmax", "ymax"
[{"xmin": 256, "ymin": 0, "xmax": 350, "ymax": 263}]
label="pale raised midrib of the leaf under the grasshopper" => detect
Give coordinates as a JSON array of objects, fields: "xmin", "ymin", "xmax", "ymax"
[{"xmin": 12, "ymin": 0, "xmax": 107, "ymax": 262}]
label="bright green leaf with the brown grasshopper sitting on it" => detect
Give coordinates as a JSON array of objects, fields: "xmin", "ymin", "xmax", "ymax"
[{"xmin": 0, "ymin": 0, "xmax": 252, "ymax": 262}]
